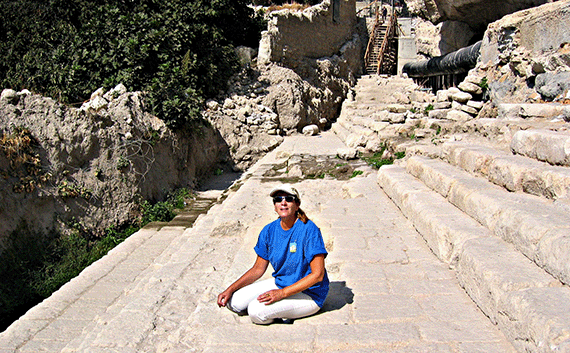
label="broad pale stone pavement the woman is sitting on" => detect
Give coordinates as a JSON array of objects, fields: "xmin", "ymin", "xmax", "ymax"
[{"xmin": 0, "ymin": 132, "xmax": 515, "ymax": 353}]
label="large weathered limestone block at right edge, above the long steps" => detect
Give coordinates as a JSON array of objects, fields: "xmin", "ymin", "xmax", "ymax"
[{"xmin": 511, "ymin": 130, "xmax": 570, "ymax": 165}]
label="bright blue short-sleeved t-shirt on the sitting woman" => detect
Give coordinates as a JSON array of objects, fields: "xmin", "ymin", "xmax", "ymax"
[{"xmin": 254, "ymin": 218, "xmax": 329, "ymax": 307}]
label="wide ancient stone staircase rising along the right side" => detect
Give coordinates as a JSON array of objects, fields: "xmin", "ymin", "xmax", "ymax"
[{"xmin": 333, "ymin": 78, "xmax": 570, "ymax": 352}]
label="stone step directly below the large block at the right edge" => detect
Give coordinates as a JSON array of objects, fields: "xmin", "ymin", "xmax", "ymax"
[{"xmin": 406, "ymin": 141, "xmax": 570, "ymax": 202}]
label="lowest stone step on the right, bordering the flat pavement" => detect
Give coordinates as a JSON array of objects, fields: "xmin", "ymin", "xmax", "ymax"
[{"xmin": 378, "ymin": 165, "xmax": 570, "ymax": 352}]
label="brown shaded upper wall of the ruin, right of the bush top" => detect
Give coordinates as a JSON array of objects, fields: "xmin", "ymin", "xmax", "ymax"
[{"xmin": 258, "ymin": 0, "xmax": 356, "ymax": 66}]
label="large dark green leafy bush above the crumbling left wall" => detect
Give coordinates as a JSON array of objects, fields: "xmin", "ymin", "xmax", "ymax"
[{"xmin": 0, "ymin": 0, "xmax": 263, "ymax": 127}]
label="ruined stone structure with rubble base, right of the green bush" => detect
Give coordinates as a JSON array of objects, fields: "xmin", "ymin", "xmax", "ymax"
[{"xmin": 205, "ymin": 0, "xmax": 366, "ymax": 170}]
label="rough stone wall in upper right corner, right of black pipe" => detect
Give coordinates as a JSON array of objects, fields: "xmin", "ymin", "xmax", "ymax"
[{"xmin": 477, "ymin": 1, "xmax": 570, "ymax": 103}]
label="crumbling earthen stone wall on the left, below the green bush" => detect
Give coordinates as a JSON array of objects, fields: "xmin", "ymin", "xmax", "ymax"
[{"xmin": 0, "ymin": 85, "xmax": 228, "ymax": 243}]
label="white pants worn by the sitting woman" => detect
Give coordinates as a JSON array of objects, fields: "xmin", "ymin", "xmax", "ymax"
[{"xmin": 227, "ymin": 278, "xmax": 320, "ymax": 325}]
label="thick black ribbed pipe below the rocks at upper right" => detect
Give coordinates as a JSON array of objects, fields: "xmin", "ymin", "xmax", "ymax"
[{"xmin": 402, "ymin": 41, "xmax": 481, "ymax": 77}]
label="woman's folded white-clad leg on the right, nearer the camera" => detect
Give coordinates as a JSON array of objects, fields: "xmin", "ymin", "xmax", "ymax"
[{"xmin": 247, "ymin": 293, "xmax": 320, "ymax": 325}]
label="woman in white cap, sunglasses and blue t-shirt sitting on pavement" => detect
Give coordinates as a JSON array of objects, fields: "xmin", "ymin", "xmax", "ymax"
[{"xmin": 218, "ymin": 185, "xmax": 329, "ymax": 324}]
